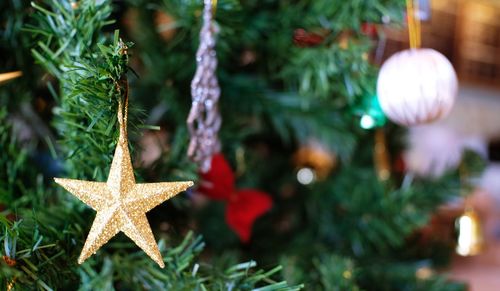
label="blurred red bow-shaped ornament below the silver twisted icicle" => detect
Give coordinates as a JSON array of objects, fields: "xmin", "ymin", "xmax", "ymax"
[{"xmin": 198, "ymin": 154, "xmax": 273, "ymax": 242}]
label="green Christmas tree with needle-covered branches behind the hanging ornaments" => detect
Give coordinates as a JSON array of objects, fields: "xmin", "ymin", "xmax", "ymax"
[{"xmin": 0, "ymin": 0, "xmax": 480, "ymax": 290}]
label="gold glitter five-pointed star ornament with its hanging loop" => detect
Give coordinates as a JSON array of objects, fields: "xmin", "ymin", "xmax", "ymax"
[{"xmin": 54, "ymin": 85, "xmax": 193, "ymax": 268}]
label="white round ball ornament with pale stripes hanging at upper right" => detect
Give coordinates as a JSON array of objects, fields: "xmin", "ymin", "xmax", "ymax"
[{"xmin": 377, "ymin": 48, "xmax": 458, "ymax": 126}]
